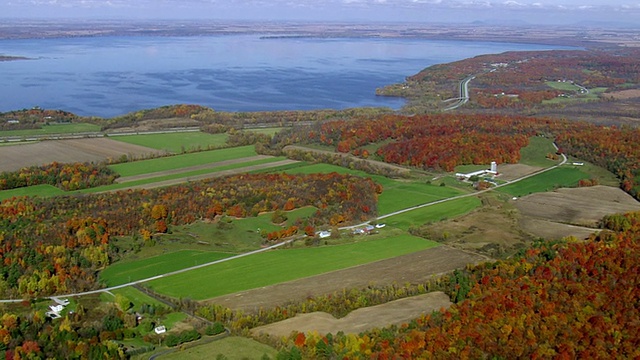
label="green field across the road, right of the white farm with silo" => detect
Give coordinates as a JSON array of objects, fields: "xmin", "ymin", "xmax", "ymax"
[{"xmin": 498, "ymin": 165, "xmax": 591, "ymax": 196}]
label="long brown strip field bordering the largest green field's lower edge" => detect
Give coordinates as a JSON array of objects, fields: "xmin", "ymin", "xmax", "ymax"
[{"xmin": 207, "ymin": 246, "xmax": 488, "ymax": 312}]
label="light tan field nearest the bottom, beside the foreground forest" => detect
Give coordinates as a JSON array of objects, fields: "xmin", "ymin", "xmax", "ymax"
[{"xmin": 251, "ymin": 291, "xmax": 451, "ymax": 337}]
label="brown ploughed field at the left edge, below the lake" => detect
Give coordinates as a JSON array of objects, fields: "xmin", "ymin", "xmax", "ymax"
[{"xmin": 0, "ymin": 138, "xmax": 164, "ymax": 172}]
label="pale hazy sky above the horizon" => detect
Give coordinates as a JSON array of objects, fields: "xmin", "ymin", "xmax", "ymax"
[{"xmin": 0, "ymin": 0, "xmax": 640, "ymax": 25}]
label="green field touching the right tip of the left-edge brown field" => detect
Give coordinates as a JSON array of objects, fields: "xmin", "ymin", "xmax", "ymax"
[{"xmin": 109, "ymin": 132, "xmax": 229, "ymax": 153}]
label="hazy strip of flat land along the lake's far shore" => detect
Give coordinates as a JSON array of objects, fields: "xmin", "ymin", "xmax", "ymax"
[{"xmin": 0, "ymin": 20, "xmax": 640, "ymax": 48}]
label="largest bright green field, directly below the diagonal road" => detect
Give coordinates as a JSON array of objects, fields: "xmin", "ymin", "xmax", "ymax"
[{"xmin": 147, "ymin": 235, "xmax": 437, "ymax": 300}]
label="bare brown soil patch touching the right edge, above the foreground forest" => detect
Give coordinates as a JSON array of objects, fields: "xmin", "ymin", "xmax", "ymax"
[{"xmin": 515, "ymin": 186, "xmax": 640, "ymax": 227}]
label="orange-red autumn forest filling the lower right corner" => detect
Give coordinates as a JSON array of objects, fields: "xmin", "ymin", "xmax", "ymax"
[{"xmin": 284, "ymin": 213, "xmax": 640, "ymax": 359}]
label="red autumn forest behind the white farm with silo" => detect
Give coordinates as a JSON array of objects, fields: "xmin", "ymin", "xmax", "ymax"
[{"xmin": 268, "ymin": 114, "xmax": 640, "ymax": 199}]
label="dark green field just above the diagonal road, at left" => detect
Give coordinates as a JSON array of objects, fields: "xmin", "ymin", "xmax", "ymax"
[{"xmin": 100, "ymin": 250, "xmax": 234, "ymax": 286}]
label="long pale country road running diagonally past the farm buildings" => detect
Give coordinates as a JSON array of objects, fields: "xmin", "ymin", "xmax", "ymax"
[{"xmin": 0, "ymin": 148, "xmax": 567, "ymax": 303}]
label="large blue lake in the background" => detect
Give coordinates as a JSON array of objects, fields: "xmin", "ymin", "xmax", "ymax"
[{"xmin": 0, "ymin": 35, "xmax": 568, "ymax": 117}]
